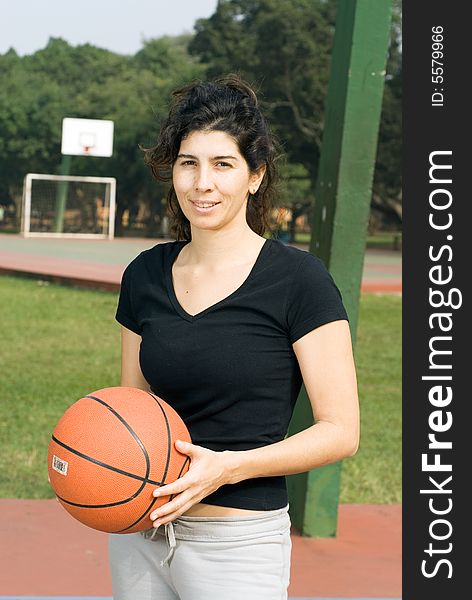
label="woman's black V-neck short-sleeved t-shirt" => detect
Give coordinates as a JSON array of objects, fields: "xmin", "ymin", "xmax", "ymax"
[{"xmin": 116, "ymin": 240, "xmax": 347, "ymax": 510}]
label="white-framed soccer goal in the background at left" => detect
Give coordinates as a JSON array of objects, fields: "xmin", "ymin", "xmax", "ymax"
[{"xmin": 21, "ymin": 173, "xmax": 116, "ymax": 239}]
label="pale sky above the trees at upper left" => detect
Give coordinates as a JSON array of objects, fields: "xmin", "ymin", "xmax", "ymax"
[{"xmin": 0, "ymin": 0, "xmax": 217, "ymax": 56}]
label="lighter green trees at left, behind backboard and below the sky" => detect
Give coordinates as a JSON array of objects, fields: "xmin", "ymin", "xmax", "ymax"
[{"xmin": 0, "ymin": 36, "xmax": 204, "ymax": 235}]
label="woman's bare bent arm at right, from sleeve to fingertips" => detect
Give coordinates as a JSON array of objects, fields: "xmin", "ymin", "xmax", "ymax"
[{"xmin": 151, "ymin": 321, "xmax": 359, "ymax": 527}]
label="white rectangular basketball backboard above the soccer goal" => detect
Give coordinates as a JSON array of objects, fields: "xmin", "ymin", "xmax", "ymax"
[{"xmin": 61, "ymin": 117, "xmax": 114, "ymax": 157}]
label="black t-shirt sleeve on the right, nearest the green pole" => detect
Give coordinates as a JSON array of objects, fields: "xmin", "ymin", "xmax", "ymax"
[{"xmin": 287, "ymin": 252, "xmax": 348, "ymax": 344}]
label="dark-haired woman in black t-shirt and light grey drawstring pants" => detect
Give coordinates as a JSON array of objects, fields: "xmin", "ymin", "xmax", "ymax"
[{"xmin": 110, "ymin": 75, "xmax": 359, "ymax": 600}]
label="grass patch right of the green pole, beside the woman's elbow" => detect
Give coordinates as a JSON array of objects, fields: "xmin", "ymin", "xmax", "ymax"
[{"xmin": 341, "ymin": 294, "xmax": 402, "ymax": 504}]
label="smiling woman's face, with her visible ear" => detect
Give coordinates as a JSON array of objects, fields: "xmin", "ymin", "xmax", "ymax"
[{"xmin": 172, "ymin": 131, "xmax": 264, "ymax": 229}]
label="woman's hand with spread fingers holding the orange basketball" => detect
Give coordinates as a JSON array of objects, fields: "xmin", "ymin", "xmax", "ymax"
[{"xmin": 151, "ymin": 440, "xmax": 233, "ymax": 527}]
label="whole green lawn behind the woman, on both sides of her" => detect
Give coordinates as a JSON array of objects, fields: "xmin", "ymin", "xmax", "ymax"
[{"xmin": 0, "ymin": 277, "xmax": 401, "ymax": 503}]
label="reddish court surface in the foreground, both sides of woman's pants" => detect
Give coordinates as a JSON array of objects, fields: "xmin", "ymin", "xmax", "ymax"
[{"xmin": 0, "ymin": 499, "xmax": 401, "ymax": 600}]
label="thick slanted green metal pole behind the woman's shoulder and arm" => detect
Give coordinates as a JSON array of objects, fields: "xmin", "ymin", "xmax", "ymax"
[{"xmin": 288, "ymin": 0, "xmax": 391, "ymax": 537}]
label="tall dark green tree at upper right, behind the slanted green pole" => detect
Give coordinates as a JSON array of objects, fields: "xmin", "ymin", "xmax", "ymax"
[{"xmin": 189, "ymin": 0, "xmax": 401, "ymax": 231}]
